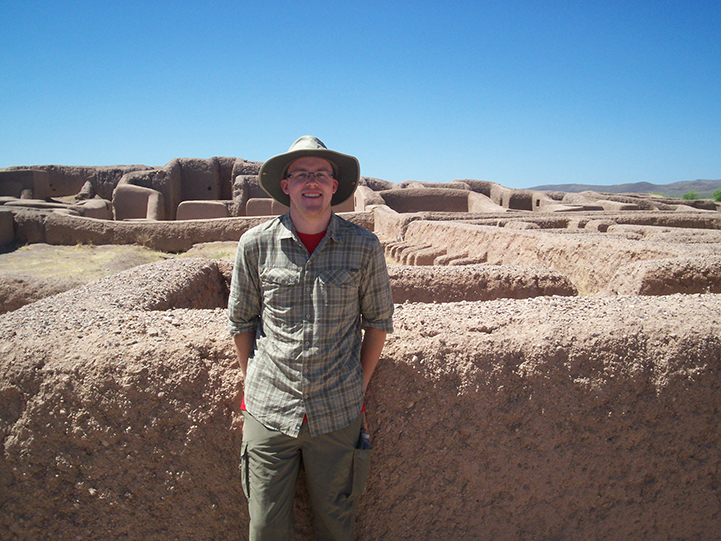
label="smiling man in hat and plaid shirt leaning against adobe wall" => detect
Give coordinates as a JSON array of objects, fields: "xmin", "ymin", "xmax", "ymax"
[{"xmin": 228, "ymin": 136, "xmax": 393, "ymax": 540}]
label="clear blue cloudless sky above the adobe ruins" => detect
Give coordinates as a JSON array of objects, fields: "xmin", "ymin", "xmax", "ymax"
[{"xmin": 0, "ymin": 0, "xmax": 721, "ymax": 188}]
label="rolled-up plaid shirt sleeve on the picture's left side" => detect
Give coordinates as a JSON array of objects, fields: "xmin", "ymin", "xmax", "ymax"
[{"xmin": 228, "ymin": 236, "xmax": 261, "ymax": 336}]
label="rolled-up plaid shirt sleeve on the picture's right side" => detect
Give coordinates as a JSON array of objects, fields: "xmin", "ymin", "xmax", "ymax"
[{"xmin": 360, "ymin": 239, "xmax": 393, "ymax": 333}]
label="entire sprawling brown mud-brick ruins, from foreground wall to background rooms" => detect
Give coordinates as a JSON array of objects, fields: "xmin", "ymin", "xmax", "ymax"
[{"xmin": 0, "ymin": 155, "xmax": 721, "ymax": 541}]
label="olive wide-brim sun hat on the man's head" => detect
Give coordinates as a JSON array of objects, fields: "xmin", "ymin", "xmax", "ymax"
[{"xmin": 258, "ymin": 135, "xmax": 360, "ymax": 207}]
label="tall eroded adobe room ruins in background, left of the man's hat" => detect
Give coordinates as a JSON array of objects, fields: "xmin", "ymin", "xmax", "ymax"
[{"xmin": 0, "ymin": 157, "xmax": 353, "ymax": 228}]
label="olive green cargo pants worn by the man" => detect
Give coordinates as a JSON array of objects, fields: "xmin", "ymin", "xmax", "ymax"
[{"xmin": 241, "ymin": 412, "xmax": 370, "ymax": 541}]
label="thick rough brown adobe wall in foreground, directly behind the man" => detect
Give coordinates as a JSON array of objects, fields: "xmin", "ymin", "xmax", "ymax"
[{"xmin": 0, "ymin": 260, "xmax": 721, "ymax": 541}]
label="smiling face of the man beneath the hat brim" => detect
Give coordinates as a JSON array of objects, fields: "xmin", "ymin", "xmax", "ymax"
[{"xmin": 280, "ymin": 157, "xmax": 338, "ymax": 215}]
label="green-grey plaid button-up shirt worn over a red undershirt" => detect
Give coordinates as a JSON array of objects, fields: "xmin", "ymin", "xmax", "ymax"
[{"xmin": 228, "ymin": 214, "xmax": 393, "ymax": 437}]
